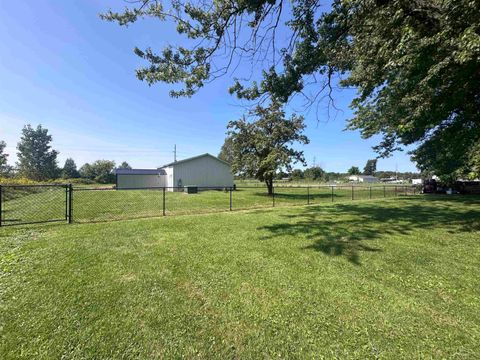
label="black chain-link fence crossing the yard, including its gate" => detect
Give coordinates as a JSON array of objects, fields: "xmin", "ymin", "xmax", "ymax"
[{"xmin": 0, "ymin": 184, "xmax": 419, "ymax": 226}]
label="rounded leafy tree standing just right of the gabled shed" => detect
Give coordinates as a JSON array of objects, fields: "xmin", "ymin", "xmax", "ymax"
[{"xmin": 228, "ymin": 100, "xmax": 308, "ymax": 195}]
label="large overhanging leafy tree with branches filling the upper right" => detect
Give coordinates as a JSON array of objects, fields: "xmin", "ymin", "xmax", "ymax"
[{"xmin": 101, "ymin": 0, "xmax": 480, "ymax": 179}]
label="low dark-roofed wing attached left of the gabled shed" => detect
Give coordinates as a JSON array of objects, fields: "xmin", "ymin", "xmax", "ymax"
[{"xmin": 114, "ymin": 169, "xmax": 167, "ymax": 189}]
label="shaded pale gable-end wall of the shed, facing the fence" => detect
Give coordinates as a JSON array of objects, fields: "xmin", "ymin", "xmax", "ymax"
[{"xmin": 173, "ymin": 156, "xmax": 233, "ymax": 187}]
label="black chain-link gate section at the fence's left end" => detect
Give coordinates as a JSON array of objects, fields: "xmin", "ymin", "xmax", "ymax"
[{"xmin": 0, "ymin": 185, "xmax": 72, "ymax": 226}]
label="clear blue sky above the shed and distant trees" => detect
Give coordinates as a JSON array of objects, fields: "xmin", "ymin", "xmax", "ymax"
[{"xmin": 0, "ymin": 0, "xmax": 415, "ymax": 172}]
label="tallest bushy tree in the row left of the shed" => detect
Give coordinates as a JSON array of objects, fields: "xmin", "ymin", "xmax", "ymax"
[{"xmin": 17, "ymin": 125, "xmax": 58, "ymax": 180}]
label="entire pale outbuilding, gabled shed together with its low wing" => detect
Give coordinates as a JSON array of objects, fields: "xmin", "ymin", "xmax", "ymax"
[{"xmin": 114, "ymin": 154, "xmax": 233, "ymax": 191}]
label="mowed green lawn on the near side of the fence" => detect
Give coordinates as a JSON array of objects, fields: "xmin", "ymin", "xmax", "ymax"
[{"xmin": 0, "ymin": 196, "xmax": 480, "ymax": 359}]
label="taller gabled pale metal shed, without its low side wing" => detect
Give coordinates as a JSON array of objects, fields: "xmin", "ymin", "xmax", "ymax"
[{"xmin": 159, "ymin": 154, "xmax": 233, "ymax": 191}]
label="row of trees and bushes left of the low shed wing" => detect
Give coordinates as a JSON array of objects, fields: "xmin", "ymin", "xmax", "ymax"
[{"xmin": 0, "ymin": 124, "xmax": 131, "ymax": 184}]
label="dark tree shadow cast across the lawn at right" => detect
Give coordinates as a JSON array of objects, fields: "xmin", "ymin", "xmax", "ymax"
[{"xmin": 259, "ymin": 196, "xmax": 480, "ymax": 265}]
